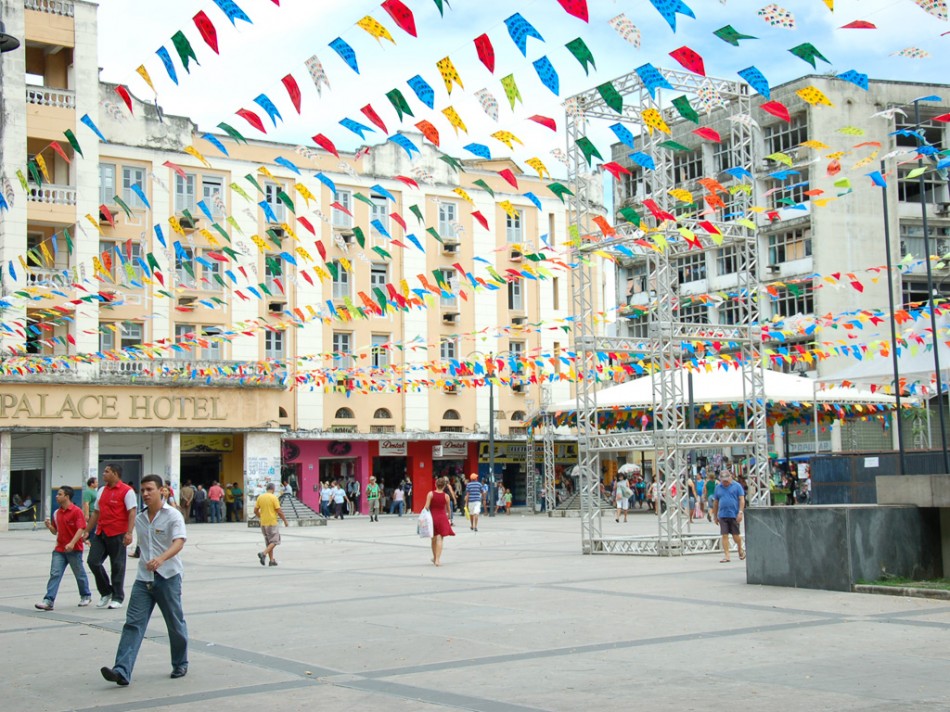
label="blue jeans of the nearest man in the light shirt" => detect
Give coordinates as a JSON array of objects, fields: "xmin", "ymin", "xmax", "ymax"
[{"xmin": 114, "ymin": 574, "xmax": 188, "ymax": 680}]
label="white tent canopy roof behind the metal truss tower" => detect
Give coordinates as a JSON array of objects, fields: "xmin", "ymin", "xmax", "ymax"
[{"xmin": 547, "ymin": 367, "xmax": 895, "ymax": 413}]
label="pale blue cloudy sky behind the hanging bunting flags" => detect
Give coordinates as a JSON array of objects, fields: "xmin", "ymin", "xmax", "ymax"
[{"xmin": 99, "ymin": 0, "xmax": 950, "ymax": 170}]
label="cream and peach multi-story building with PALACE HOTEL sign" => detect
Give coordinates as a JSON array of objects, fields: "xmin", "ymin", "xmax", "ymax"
[{"xmin": 0, "ymin": 0, "xmax": 600, "ymax": 526}]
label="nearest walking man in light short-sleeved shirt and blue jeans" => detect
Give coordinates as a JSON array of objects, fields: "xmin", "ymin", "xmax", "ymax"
[{"xmin": 99, "ymin": 475, "xmax": 188, "ymax": 686}]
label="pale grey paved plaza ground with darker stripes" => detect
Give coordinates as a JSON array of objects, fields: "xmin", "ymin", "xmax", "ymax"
[{"xmin": 0, "ymin": 506, "xmax": 950, "ymax": 712}]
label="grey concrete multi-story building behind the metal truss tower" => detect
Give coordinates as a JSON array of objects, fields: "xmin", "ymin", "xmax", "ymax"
[{"xmin": 613, "ymin": 76, "xmax": 950, "ymax": 454}]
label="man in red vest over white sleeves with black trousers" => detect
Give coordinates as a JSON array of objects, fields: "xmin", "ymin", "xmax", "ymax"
[{"xmin": 85, "ymin": 465, "xmax": 136, "ymax": 608}]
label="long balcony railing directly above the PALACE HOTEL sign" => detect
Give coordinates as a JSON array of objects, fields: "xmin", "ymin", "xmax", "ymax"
[{"xmin": 0, "ymin": 356, "xmax": 287, "ymax": 388}]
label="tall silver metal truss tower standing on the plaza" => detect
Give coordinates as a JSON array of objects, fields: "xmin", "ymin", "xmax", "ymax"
[{"xmin": 566, "ymin": 68, "xmax": 769, "ymax": 556}]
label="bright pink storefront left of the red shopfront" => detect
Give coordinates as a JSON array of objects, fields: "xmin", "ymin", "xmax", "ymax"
[{"xmin": 283, "ymin": 440, "xmax": 372, "ymax": 514}]
